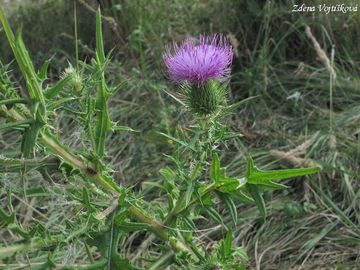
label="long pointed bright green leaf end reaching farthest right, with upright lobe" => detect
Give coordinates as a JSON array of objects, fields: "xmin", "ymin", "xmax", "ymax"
[{"xmin": 246, "ymin": 158, "xmax": 320, "ymax": 188}]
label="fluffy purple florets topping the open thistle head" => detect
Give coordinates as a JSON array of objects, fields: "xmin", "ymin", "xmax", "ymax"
[{"xmin": 163, "ymin": 34, "xmax": 233, "ymax": 85}]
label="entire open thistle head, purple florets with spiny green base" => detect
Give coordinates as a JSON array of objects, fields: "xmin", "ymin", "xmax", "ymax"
[{"xmin": 163, "ymin": 35, "xmax": 233, "ymax": 116}]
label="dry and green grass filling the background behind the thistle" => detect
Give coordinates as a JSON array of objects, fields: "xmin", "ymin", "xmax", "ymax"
[{"xmin": 0, "ymin": 0, "xmax": 360, "ymax": 269}]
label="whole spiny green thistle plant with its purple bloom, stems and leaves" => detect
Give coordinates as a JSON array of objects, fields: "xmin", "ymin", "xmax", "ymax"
[{"xmin": 0, "ymin": 9, "xmax": 319, "ymax": 270}]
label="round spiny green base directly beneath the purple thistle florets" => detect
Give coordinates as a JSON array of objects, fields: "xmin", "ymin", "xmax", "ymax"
[{"xmin": 182, "ymin": 80, "xmax": 227, "ymax": 116}]
